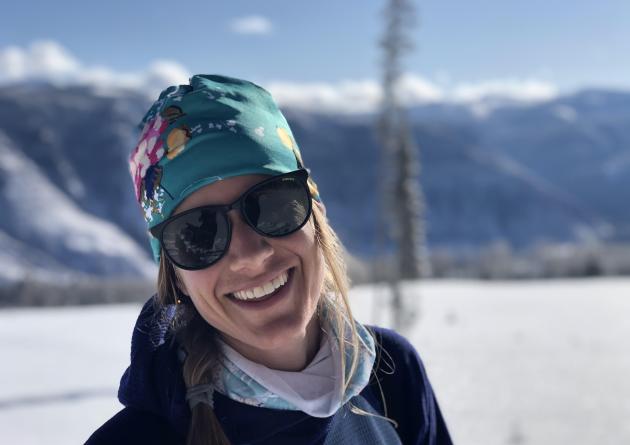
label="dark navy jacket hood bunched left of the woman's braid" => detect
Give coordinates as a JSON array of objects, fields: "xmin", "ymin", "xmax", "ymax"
[{"xmin": 118, "ymin": 296, "xmax": 190, "ymax": 435}]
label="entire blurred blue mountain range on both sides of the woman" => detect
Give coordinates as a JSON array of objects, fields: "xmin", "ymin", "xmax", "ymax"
[{"xmin": 0, "ymin": 84, "xmax": 630, "ymax": 281}]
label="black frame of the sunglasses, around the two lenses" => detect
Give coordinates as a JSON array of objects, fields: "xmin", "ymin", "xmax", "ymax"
[{"xmin": 149, "ymin": 168, "xmax": 313, "ymax": 270}]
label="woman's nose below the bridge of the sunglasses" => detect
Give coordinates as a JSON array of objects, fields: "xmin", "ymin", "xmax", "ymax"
[{"xmin": 227, "ymin": 210, "xmax": 274, "ymax": 275}]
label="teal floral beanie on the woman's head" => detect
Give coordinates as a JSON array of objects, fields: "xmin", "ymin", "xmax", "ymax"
[{"xmin": 129, "ymin": 74, "xmax": 320, "ymax": 262}]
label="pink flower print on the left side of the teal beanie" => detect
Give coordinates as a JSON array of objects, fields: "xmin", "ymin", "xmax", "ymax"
[{"xmin": 129, "ymin": 115, "xmax": 168, "ymax": 201}]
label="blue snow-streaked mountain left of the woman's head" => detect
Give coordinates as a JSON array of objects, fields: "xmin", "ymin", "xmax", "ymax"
[{"xmin": 0, "ymin": 86, "xmax": 155, "ymax": 282}]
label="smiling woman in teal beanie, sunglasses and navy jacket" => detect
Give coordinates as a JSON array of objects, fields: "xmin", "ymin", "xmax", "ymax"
[{"xmin": 87, "ymin": 75, "xmax": 451, "ymax": 445}]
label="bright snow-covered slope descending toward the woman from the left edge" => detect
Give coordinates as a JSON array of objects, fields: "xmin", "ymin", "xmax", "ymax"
[{"xmin": 0, "ymin": 131, "xmax": 154, "ymax": 281}]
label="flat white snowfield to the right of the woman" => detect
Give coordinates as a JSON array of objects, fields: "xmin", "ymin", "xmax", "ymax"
[{"xmin": 355, "ymin": 279, "xmax": 630, "ymax": 445}]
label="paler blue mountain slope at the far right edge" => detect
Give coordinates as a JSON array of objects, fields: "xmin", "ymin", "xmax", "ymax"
[{"xmin": 483, "ymin": 90, "xmax": 630, "ymax": 239}]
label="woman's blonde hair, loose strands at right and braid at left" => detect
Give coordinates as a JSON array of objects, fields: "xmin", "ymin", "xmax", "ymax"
[{"xmin": 158, "ymin": 205, "xmax": 367, "ymax": 445}]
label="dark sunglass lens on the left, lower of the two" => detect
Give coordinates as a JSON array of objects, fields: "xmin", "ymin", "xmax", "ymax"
[{"xmin": 162, "ymin": 209, "xmax": 229, "ymax": 269}]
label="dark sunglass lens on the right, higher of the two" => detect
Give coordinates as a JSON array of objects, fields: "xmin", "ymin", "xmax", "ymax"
[{"xmin": 243, "ymin": 177, "xmax": 311, "ymax": 236}]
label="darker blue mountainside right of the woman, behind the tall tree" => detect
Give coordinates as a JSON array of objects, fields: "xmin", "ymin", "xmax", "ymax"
[{"xmin": 287, "ymin": 107, "xmax": 630, "ymax": 255}]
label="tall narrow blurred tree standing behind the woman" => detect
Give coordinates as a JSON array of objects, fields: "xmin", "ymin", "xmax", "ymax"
[{"xmin": 378, "ymin": 0, "xmax": 427, "ymax": 330}]
